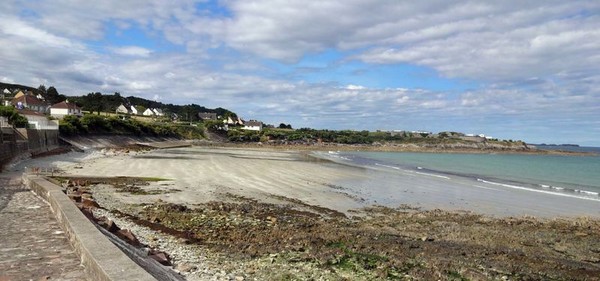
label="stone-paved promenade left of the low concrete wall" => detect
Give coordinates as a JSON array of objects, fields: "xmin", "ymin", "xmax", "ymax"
[{"xmin": 0, "ymin": 173, "xmax": 87, "ymax": 281}]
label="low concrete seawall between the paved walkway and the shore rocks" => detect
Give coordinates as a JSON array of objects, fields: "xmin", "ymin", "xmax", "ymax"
[{"xmin": 23, "ymin": 175, "xmax": 156, "ymax": 281}]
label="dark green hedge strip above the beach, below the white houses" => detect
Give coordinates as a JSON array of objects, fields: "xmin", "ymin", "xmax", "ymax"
[{"xmin": 59, "ymin": 114, "xmax": 204, "ymax": 139}]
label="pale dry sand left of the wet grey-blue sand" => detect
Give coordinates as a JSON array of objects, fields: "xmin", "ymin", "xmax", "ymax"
[{"xmin": 30, "ymin": 147, "xmax": 363, "ymax": 212}]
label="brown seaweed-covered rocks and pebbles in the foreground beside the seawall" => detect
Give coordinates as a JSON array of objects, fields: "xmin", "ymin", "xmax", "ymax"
[{"xmin": 54, "ymin": 174, "xmax": 600, "ymax": 280}]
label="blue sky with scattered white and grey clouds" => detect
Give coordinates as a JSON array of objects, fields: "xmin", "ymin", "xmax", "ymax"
[{"xmin": 0, "ymin": 0, "xmax": 600, "ymax": 146}]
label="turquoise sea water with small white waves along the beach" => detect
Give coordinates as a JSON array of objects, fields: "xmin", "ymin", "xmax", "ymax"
[{"xmin": 335, "ymin": 148, "xmax": 600, "ymax": 199}]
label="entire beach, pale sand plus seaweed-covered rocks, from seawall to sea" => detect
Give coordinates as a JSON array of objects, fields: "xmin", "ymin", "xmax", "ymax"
[{"xmin": 10, "ymin": 146, "xmax": 600, "ymax": 280}]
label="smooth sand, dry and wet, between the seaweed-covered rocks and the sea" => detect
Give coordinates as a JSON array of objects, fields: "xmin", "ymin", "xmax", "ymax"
[{"xmin": 29, "ymin": 146, "xmax": 600, "ymax": 218}]
